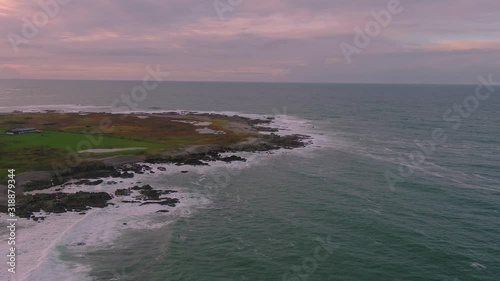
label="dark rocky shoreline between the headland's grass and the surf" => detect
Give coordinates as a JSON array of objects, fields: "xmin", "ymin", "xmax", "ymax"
[{"xmin": 0, "ymin": 112, "xmax": 310, "ymax": 220}]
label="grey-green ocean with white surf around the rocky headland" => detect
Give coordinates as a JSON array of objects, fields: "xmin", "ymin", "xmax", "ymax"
[{"xmin": 0, "ymin": 80, "xmax": 500, "ymax": 281}]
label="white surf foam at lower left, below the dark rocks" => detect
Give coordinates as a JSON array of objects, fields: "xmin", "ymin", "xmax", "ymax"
[{"xmin": 16, "ymin": 175, "xmax": 210, "ymax": 280}]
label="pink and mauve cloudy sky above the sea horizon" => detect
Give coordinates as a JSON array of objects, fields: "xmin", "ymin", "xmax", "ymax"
[{"xmin": 0, "ymin": 0, "xmax": 500, "ymax": 84}]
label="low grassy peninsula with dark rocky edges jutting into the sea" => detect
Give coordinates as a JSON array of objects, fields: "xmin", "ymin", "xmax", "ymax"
[{"xmin": 0, "ymin": 111, "xmax": 309, "ymax": 220}]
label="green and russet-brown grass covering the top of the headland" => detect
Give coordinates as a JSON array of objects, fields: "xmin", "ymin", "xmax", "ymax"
[{"xmin": 0, "ymin": 113, "xmax": 249, "ymax": 181}]
